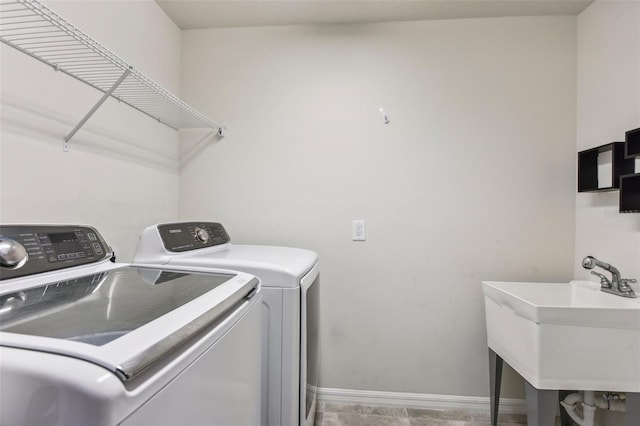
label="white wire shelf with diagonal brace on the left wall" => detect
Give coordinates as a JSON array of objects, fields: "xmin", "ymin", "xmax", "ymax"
[{"xmin": 0, "ymin": 0, "xmax": 224, "ymax": 141}]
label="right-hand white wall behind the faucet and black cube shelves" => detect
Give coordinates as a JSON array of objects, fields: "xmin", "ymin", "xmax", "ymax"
[{"xmin": 574, "ymin": 1, "xmax": 640, "ymax": 279}]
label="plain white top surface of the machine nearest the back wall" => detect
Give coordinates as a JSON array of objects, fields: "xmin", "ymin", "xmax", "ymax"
[{"xmin": 168, "ymin": 244, "xmax": 318, "ymax": 288}]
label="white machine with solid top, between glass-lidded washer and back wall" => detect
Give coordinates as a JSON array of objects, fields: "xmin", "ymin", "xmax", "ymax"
[{"xmin": 133, "ymin": 222, "xmax": 320, "ymax": 426}]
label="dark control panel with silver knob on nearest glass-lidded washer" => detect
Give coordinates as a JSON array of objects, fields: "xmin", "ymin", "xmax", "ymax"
[{"xmin": 0, "ymin": 225, "xmax": 112, "ymax": 280}]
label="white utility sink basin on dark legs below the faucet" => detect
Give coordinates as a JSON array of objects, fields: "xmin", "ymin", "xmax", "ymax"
[{"xmin": 482, "ymin": 281, "xmax": 640, "ymax": 392}]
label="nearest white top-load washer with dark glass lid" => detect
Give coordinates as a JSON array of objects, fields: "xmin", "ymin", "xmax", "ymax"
[{"xmin": 0, "ymin": 225, "xmax": 262, "ymax": 426}]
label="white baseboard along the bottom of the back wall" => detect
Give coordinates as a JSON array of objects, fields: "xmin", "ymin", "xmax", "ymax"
[{"xmin": 317, "ymin": 388, "xmax": 527, "ymax": 414}]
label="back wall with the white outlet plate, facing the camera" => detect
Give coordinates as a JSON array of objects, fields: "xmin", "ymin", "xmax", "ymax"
[{"xmin": 180, "ymin": 17, "xmax": 576, "ymax": 397}]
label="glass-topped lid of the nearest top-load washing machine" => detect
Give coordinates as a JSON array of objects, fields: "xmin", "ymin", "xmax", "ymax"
[{"xmin": 0, "ymin": 267, "xmax": 259, "ymax": 381}]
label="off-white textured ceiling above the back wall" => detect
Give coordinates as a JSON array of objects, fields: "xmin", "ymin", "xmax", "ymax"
[{"xmin": 156, "ymin": 0, "xmax": 593, "ymax": 30}]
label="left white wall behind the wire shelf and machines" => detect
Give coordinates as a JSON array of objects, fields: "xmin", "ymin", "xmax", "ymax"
[{"xmin": 0, "ymin": 1, "xmax": 181, "ymax": 260}]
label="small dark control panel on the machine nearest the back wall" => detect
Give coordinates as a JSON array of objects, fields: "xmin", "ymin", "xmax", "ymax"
[{"xmin": 158, "ymin": 222, "xmax": 230, "ymax": 253}]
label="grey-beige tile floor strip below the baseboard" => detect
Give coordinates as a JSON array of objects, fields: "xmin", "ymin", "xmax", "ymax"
[{"xmin": 315, "ymin": 402, "xmax": 527, "ymax": 426}]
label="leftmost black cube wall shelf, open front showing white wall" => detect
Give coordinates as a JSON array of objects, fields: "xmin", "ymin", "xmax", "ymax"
[{"xmin": 578, "ymin": 142, "xmax": 635, "ymax": 192}]
